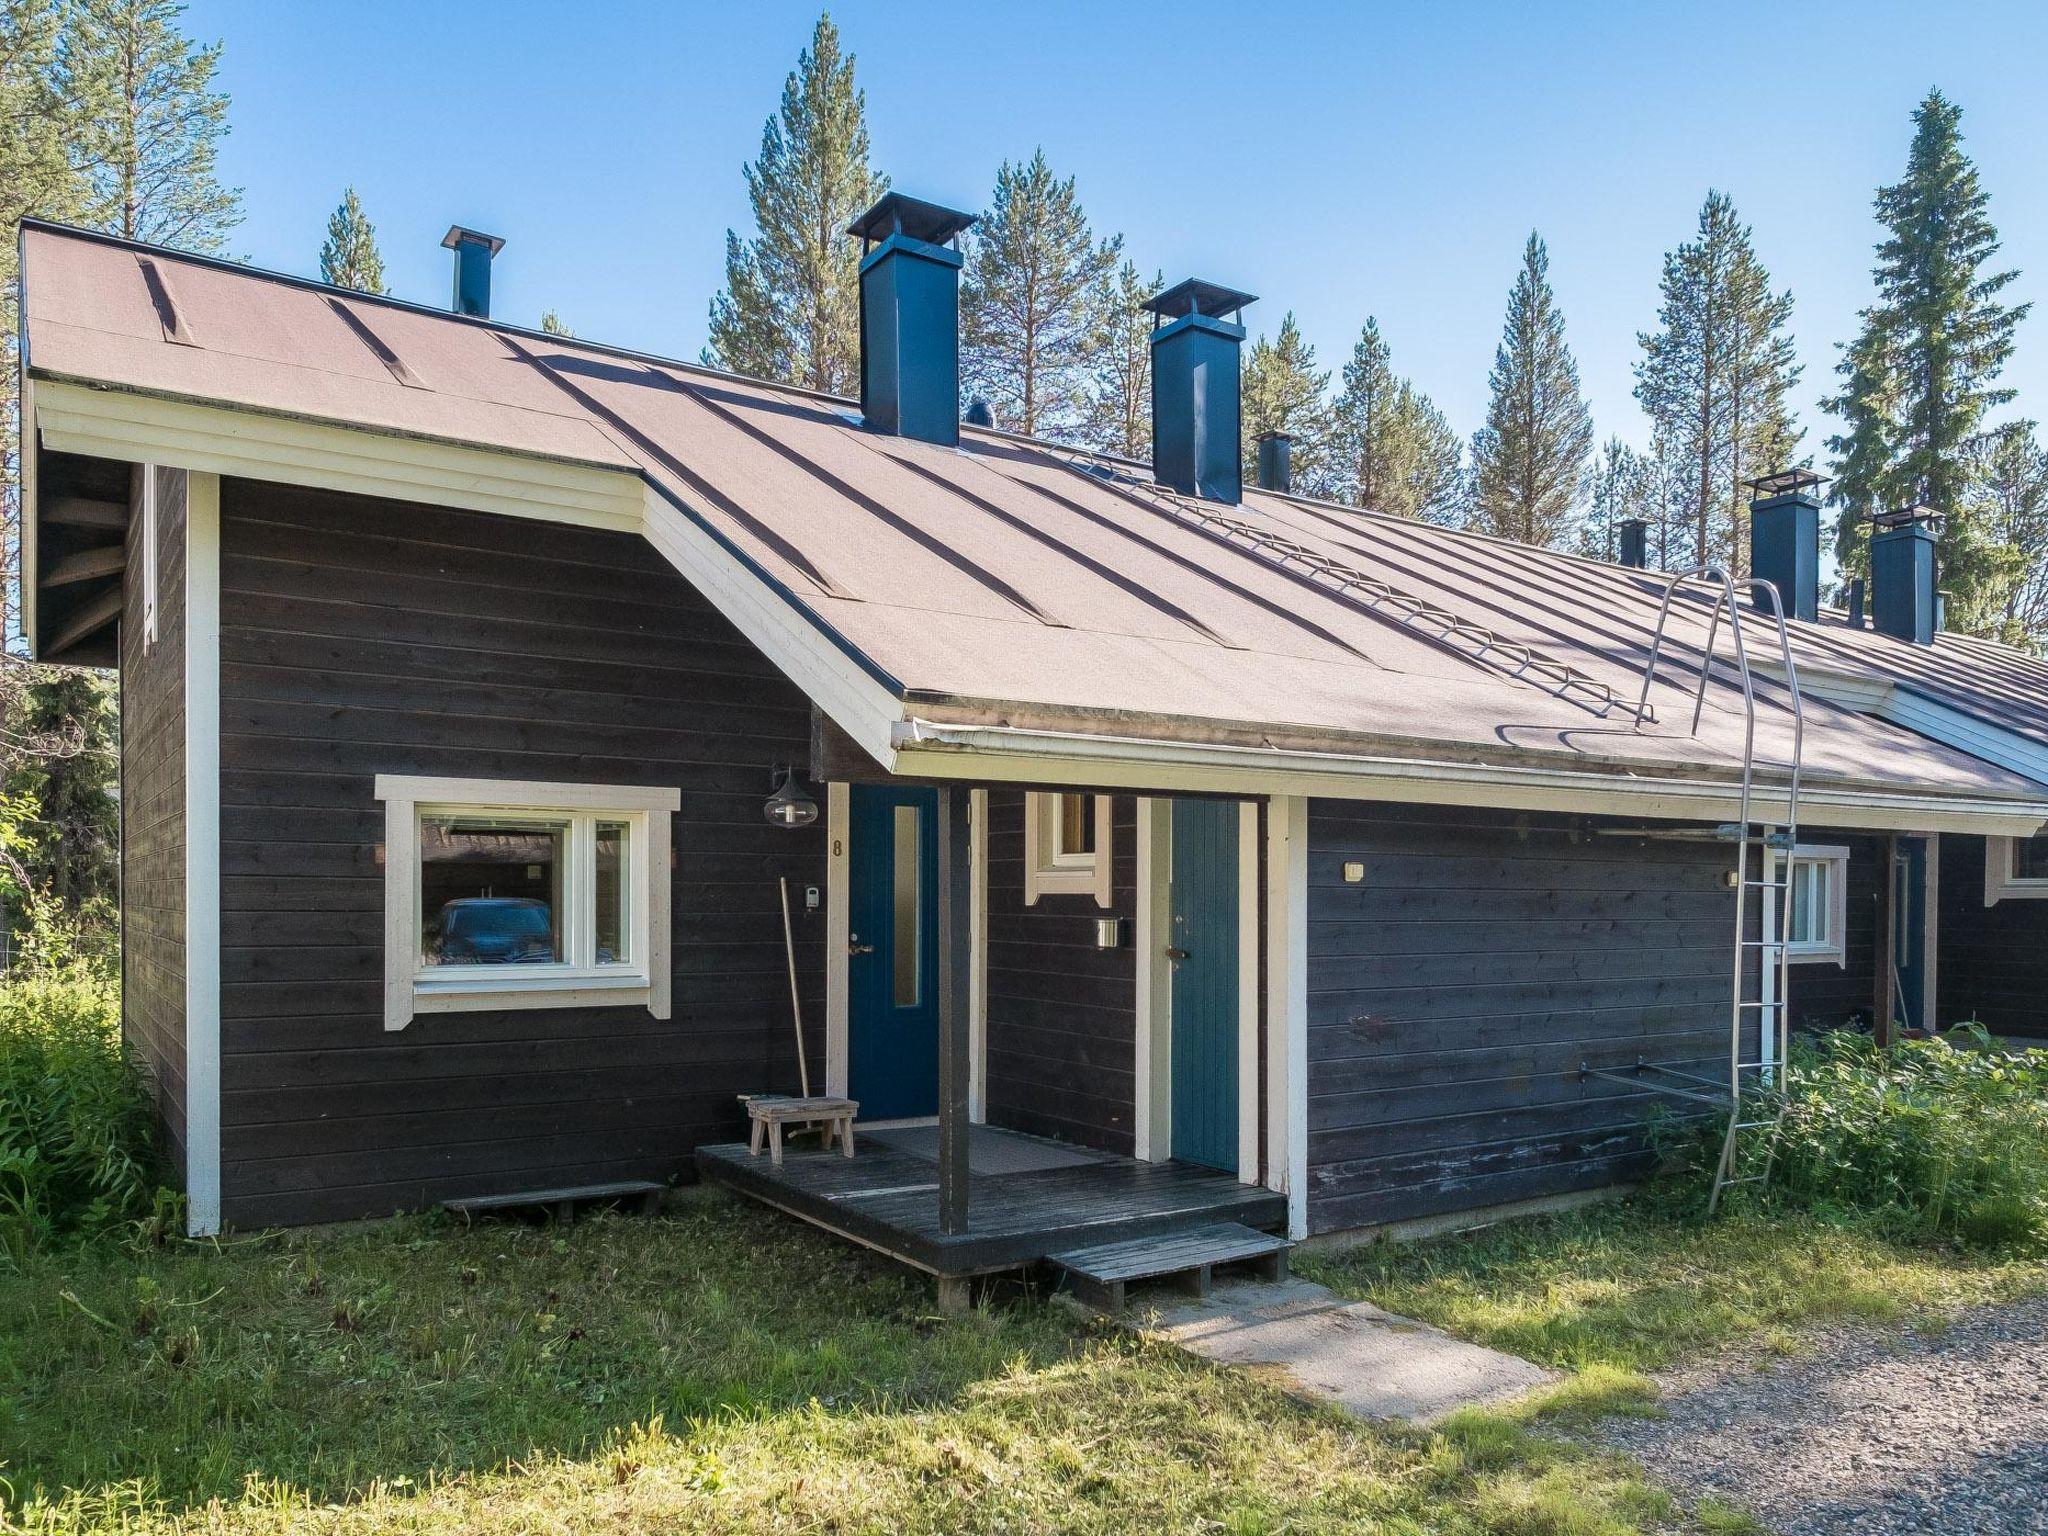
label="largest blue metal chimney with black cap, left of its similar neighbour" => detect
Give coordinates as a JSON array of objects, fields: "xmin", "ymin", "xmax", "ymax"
[{"xmin": 846, "ymin": 193, "xmax": 975, "ymax": 449}]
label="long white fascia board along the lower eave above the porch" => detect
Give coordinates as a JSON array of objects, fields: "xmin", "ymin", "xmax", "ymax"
[{"xmin": 895, "ymin": 721, "xmax": 2048, "ymax": 838}]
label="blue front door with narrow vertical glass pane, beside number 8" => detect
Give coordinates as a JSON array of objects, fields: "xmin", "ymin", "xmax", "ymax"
[{"xmin": 846, "ymin": 784, "xmax": 938, "ymax": 1120}]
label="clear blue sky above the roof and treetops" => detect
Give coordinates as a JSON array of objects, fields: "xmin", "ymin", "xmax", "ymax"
[{"xmin": 186, "ymin": 0, "xmax": 2048, "ymax": 460}]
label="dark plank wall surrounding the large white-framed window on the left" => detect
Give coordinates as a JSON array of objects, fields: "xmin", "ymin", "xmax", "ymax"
[{"xmin": 221, "ymin": 481, "xmax": 825, "ymax": 1227}]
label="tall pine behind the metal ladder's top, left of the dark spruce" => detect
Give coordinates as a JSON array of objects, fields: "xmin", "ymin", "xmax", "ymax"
[{"xmin": 1636, "ymin": 190, "xmax": 1800, "ymax": 573}]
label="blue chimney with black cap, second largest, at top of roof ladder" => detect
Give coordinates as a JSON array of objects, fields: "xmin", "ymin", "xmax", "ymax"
[{"xmin": 1145, "ymin": 279, "xmax": 1257, "ymax": 502}]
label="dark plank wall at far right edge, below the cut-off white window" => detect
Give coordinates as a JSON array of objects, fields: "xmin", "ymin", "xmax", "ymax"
[{"xmin": 1935, "ymin": 836, "xmax": 2048, "ymax": 1038}]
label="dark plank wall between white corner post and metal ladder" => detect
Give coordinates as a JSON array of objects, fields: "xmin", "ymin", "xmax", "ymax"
[{"xmin": 1309, "ymin": 801, "xmax": 1735, "ymax": 1231}]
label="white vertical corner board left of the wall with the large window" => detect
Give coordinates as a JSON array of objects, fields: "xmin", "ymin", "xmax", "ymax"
[{"xmin": 185, "ymin": 469, "xmax": 221, "ymax": 1237}]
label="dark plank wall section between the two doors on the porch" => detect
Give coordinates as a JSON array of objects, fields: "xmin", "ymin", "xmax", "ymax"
[{"xmin": 987, "ymin": 788, "xmax": 1137, "ymax": 1155}]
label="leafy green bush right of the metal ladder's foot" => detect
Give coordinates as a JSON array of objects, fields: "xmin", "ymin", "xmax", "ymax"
[{"xmin": 1712, "ymin": 1026, "xmax": 2048, "ymax": 1251}]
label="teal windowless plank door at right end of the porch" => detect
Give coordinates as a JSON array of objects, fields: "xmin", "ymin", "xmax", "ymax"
[{"xmin": 1167, "ymin": 801, "xmax": 1237, "ymax": 1174}]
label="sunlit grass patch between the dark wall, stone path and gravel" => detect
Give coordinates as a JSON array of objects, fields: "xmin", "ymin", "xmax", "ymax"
[{"xmin": 1294, "ymin": 1200, "xmax": 2048, "ymax": 1370}]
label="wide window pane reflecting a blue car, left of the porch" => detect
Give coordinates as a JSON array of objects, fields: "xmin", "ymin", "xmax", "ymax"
[{"xmin": 420, "ymin": 815, "xmax": 569, "ymax": 965}]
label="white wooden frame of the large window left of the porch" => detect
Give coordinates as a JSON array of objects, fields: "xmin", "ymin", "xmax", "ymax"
[{"xmin": 377, "ymin": 774, "xmax": 682, "ymax": 1030}]
